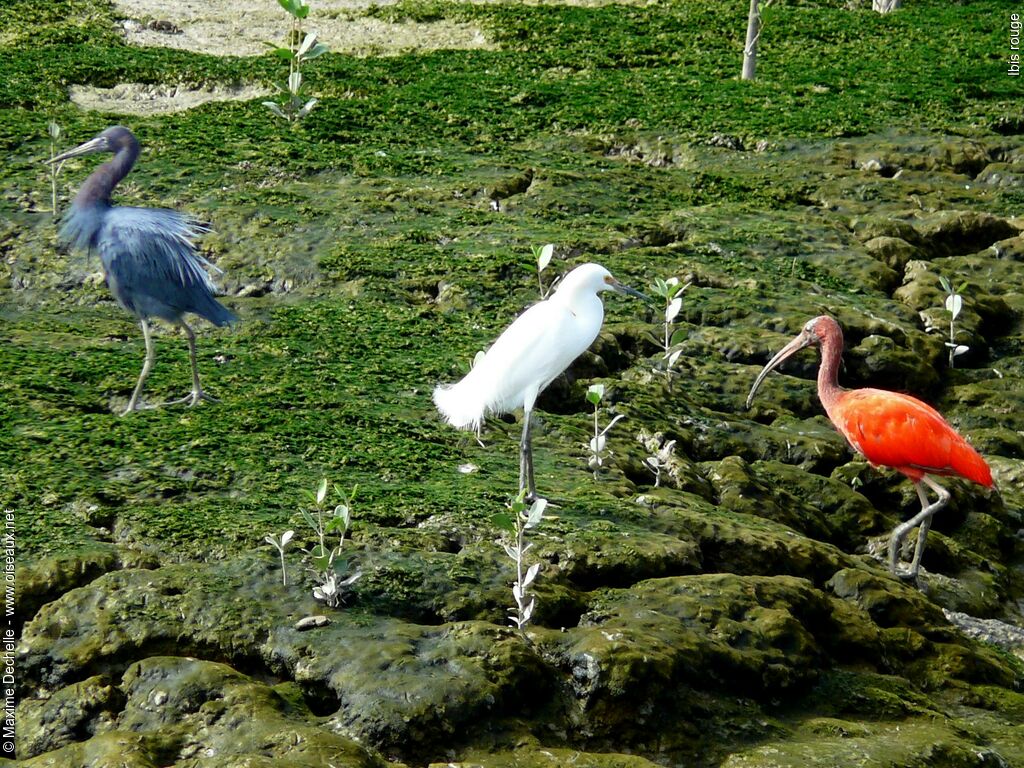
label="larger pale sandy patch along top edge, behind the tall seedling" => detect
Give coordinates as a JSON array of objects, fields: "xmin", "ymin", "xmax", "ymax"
[{"xmin": 115, "ymin": 0, "xmax": 494, "ymax": 56}]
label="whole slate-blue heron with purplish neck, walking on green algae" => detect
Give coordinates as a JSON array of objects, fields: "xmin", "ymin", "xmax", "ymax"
[{"xmin": 49, "ymin": 126, "xmax": 236, "ymax": 415}]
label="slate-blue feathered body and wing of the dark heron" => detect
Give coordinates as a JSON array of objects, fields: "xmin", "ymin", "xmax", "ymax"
[{"xmin": 94, "ymin": 206, "xmax": 234, "ymax": 325}]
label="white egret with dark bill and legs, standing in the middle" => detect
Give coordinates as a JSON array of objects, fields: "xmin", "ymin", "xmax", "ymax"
[{"xmin": 434, "ymin": 264, "xmax": 650, "ymax": 500}]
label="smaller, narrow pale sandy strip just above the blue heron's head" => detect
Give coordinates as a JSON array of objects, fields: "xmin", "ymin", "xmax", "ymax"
[{"xmin": 69, "ymin": 83, "xmax": 270, "ymax": 115}]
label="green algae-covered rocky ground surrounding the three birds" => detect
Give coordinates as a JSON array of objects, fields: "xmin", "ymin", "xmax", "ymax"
[{"xmin": 0, "ymin": 0, "xmax": 1024, "ymax": 768}]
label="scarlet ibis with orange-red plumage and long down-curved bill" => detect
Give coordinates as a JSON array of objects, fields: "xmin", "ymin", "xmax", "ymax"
[{"xmin": 746, "ymin": 315, "xmax": 992, "ymax": 580}]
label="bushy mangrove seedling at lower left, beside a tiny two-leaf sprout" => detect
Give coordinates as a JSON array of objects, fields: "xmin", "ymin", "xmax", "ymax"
[{"xmin": 299, "ymin": 477, "xmax": 362, "ymax": 608}]
